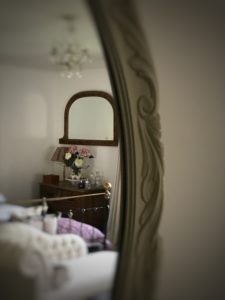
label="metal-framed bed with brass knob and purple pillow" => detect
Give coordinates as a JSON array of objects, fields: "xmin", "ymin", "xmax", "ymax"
[{"xmin": 0, "ymin": 189, "xmax": 112, "ymax": 252}]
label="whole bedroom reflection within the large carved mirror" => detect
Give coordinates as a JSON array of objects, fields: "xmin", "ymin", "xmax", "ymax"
[{"xmin": 0, "ymin": 0, "xmax": 121, "ymax": 300}]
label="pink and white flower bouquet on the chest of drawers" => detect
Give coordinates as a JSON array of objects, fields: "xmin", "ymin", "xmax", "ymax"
[{"xmin": 64, "ymin": 146, "xmax": 94, "ymax": 178}]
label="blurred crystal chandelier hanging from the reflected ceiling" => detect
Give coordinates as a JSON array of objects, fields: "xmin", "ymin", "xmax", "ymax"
[{"xmin": 50, "ymin": 15, "xmax": 92, "ymax": 78}]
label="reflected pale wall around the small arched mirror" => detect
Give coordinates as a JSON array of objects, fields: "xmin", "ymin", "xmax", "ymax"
[{"xmin": 0, "ymin": 63, "xmax": 118, "ymax": 200}]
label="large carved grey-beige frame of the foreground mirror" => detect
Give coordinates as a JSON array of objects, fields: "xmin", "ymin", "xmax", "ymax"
[{"xmin": 88, "ymin": 0, "xmax": 164, "ymax": 300}]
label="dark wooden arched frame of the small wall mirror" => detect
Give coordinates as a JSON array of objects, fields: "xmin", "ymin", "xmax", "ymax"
[{"xmin": 59, "ymin": 91, "xmax": 118, "ymax": 146}]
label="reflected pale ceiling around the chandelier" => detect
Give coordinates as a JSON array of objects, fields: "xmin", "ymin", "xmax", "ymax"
[{"xmin": 0, "ymin": 0, "xmax": 104, "ymax": 70}]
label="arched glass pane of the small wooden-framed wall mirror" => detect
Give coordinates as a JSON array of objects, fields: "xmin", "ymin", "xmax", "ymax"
[{"xmin": 68, "ymin": 97, "xmax": 113, "ymax": 140}]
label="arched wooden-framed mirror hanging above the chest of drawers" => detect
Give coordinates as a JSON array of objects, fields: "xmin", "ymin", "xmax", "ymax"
[{"xmin": 59, "ymin": 91, "xmax": 118, "ymax": 146}]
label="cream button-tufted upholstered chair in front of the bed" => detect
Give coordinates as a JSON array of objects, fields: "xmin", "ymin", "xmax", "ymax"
[{"xmin": 0, "ymin": 222, "xmax": 117, "ymax": 300}]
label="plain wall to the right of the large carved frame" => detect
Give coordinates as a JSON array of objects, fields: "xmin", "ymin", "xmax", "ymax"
[{"xmin": 139, "ymin": 0, "xmax": 225, "ymax": 300}]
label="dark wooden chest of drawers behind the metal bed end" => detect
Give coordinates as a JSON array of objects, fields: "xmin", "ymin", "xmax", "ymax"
[{"xmin": 40, "ymin": 181, "xmax": 109, "ymax": 232}]
